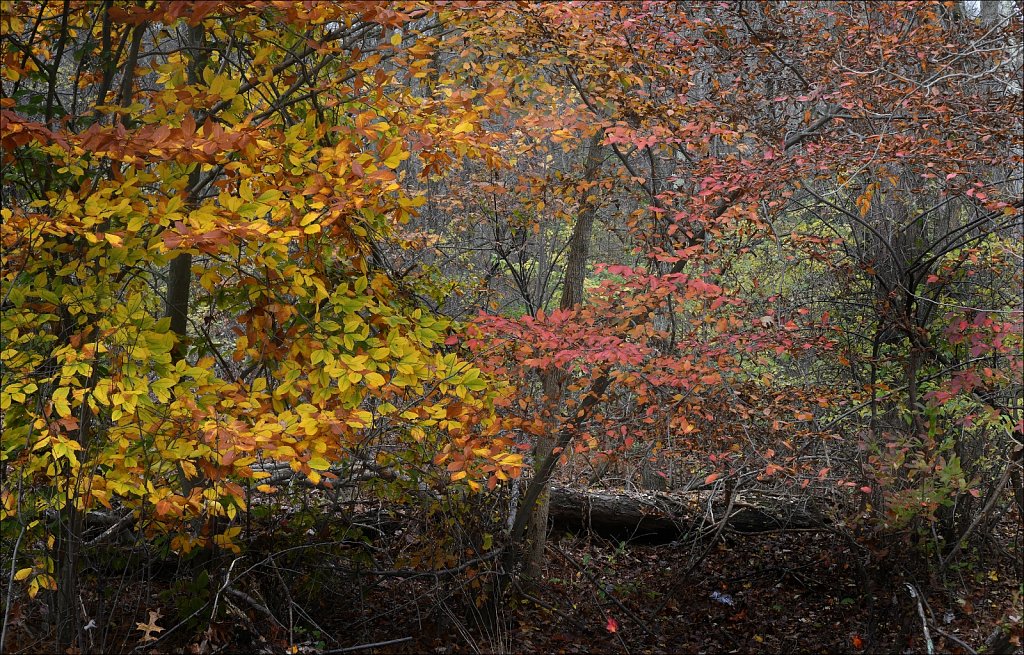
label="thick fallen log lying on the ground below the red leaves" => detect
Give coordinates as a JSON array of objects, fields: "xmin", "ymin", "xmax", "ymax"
[{"xmin": 550, "ymin": 486, "xmax": 827, "ymax": 542}]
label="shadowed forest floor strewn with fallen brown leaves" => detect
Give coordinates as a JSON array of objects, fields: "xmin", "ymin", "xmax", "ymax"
[{"xmin": 7, "ymin": 499, "xmax": 1024, "ymax": 655}]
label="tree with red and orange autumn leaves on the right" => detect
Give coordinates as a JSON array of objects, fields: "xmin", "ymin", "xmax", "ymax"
[{"xmin": 462, "ymin": 3, "xmax": 1021, "ymax": 581}]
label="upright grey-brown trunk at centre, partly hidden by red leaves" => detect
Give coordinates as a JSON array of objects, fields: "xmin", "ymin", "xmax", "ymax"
[{"xmin": 520, "ymin": 131, "xmax": 603, "ymax": 579}]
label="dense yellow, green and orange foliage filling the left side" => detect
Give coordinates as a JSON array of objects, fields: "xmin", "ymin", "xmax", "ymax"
[{"xmin": 0, "ymin": 3, "xmax": 521, "ymax": 588}]
